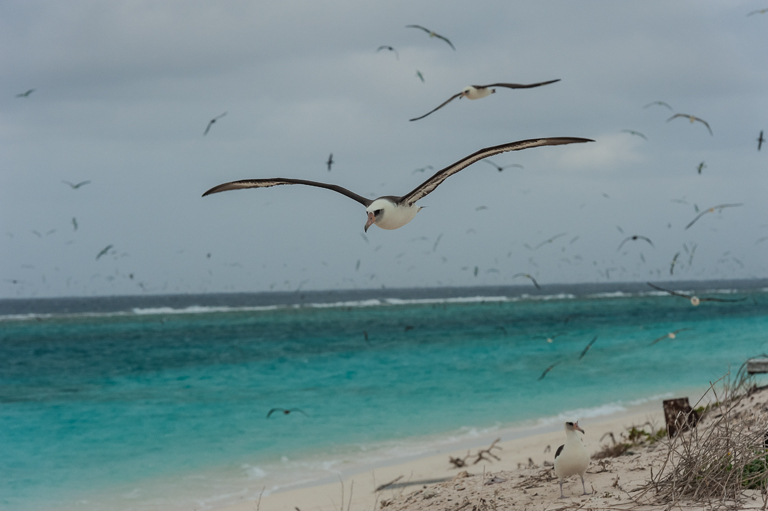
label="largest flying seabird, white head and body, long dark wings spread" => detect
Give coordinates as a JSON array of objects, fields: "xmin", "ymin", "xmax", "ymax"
[{"xmin": 203, "ymin": 137, "xmax": 594, "ymax": 231}]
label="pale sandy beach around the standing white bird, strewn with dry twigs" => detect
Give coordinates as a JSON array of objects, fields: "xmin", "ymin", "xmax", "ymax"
[{"xmin": 213, "ymin": 391, "xmax": 768, "ymax": 511}]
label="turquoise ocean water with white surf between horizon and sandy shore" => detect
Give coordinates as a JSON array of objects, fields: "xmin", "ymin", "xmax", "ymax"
[{"xmin": 0, "ymin": 282, "xmax": 768, "ymax": 511}]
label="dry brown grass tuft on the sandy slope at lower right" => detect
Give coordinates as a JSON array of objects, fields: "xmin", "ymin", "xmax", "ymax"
[{"xmin": 639, "ymin": 366, "xmax": 768, "ymax": 509}]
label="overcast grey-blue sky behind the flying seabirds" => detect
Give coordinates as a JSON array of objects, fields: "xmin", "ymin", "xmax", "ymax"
[{"xmin": 0, "ymin": 0, "xmax": 768, "ymax": 297}]
